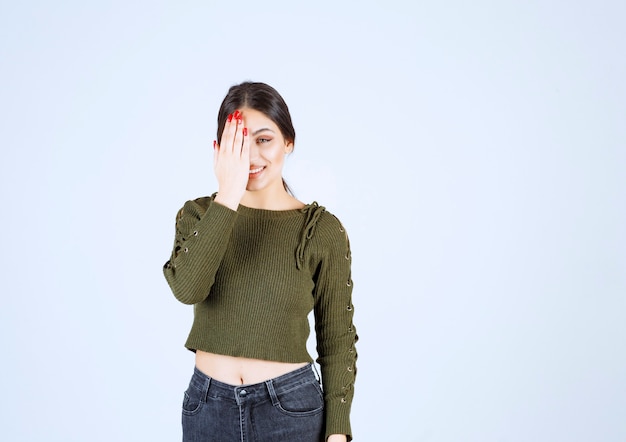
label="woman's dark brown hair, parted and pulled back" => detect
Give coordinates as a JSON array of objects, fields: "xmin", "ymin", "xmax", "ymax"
[{"xmin": 217, "ymin": 81, "xmax": 296, "ymax": 195}]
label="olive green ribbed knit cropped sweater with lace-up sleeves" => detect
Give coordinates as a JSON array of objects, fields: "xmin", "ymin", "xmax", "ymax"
[{"xmin": 163, "ymin": 195, "xmax": 358, "ymax": 440}]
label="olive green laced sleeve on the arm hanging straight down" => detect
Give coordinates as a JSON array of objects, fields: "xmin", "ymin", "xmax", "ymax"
[{"xmin": 314, "ymin": 215, "xmax": 358, "ymax": 440}]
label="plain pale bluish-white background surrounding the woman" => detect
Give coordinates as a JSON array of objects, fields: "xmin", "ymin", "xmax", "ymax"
[{"xmin": 0, "ymin": 0, "xmax": 626, "ymax": 442}]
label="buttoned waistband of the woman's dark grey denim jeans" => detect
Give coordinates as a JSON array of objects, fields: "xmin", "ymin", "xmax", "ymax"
[{"xmin": 191, "ymin": 364, "xmax": 318, "ymax": 403}]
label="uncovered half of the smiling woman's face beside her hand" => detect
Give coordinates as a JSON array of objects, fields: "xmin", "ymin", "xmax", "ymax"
[{"xmin": 240, "ymin": 108, "xmax": 293, "ymax": 191}]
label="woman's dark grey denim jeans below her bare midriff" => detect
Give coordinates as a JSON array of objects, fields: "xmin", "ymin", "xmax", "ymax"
[{"xmin": 182, "ymin": 364, "xmax": 324, "ymax": 442}]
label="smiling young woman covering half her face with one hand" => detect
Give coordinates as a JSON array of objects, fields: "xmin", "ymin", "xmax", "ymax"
[{"xmin": 164, "ymin": 82, "xmax": 358, "ymax": 442}]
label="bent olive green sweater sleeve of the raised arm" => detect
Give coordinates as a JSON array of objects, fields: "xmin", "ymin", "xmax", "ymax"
[{"xmin": 163, "ymin": 198, "xmax": 237, "ymax": 304}]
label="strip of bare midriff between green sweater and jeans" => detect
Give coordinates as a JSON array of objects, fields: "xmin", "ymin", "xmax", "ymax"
[{"xmin": 196, "ymin": 350, "xmax": 308, "ymax": 385}]
